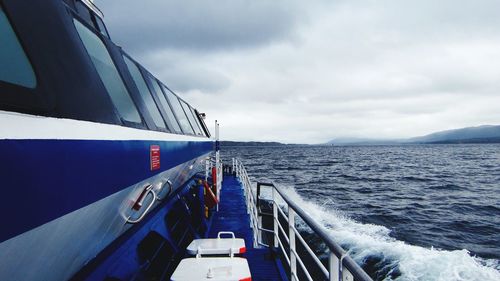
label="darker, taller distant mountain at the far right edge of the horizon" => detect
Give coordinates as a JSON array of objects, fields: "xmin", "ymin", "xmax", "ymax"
[{"xmin": 406, "ymin": 125, "xmax": 500, "ymax": 143}]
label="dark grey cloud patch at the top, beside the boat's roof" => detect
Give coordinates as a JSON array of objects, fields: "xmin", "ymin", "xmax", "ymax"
[{"xmin": 96, "ymin": 0, "xmax": 301, "ymax": 53}]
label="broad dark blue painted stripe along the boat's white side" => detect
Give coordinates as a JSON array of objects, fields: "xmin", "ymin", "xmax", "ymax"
[{"xmin": 0, "ymin": 140, "xmax": 213, "ymax": 243}]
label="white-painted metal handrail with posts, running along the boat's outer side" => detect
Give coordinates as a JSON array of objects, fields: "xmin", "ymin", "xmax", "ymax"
[{"xmin": 233, "ymin": 159, "xmax": 372, "ymax": 281}]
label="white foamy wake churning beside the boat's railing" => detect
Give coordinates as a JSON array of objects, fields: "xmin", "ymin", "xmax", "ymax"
[{"xmin": 278, "ymin": 186, "xmax": 500, "ymax": 281}]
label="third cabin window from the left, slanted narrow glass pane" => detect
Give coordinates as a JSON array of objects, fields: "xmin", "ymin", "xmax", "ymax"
[{"xmin": 123, "ymin": 56, "xmax": 167, "ymax": 129}]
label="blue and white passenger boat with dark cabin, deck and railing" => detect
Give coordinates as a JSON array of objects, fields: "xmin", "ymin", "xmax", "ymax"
[{"xmin": 0, "ymin": 0, "xmax": 371, "ymax": 280}]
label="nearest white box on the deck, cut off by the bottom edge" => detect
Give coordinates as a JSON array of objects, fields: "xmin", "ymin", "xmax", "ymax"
[{"xmin": 170, "ymin": 257, "xmax": 251, "ymax": 281}]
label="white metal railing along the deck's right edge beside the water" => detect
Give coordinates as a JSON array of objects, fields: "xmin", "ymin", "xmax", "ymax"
[{"xmin": 233, "ymin": 159, "xmax": 372, "ymax": 281}]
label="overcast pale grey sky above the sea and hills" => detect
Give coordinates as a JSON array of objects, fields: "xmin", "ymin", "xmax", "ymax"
[{"xmin": 94, "ymin": 0, "xmax": 500, "ymax": 143}]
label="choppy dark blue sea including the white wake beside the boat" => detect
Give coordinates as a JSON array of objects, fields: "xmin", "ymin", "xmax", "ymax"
[{"xmin": 222, "ymin": 144, "xmax": 500, "ymax": 281}]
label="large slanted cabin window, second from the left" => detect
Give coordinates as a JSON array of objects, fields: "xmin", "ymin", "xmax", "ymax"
[{"xmin": 73, "ymin": 19, "xmax": 141, "ymax": 123}]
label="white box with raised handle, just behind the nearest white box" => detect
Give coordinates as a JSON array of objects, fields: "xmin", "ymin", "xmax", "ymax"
[{"xmin": 187, "ymin": 231, "xmax": 246, "ymax": 256}]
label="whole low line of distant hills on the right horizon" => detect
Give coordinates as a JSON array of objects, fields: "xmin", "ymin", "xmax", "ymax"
[{"xmin": 327, "ymin": 125, "xmax": 500, "ymax": 145}]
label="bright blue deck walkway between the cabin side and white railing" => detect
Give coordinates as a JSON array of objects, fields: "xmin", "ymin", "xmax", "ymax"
[{"xmin": 209, "ymin": 175, "xmax": 282, "ymax": 281}]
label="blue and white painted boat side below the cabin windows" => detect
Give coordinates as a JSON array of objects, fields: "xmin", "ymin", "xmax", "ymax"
[{"xmin": 0, "ymin": 112, "xmax": 213, "ymax": 280}]
